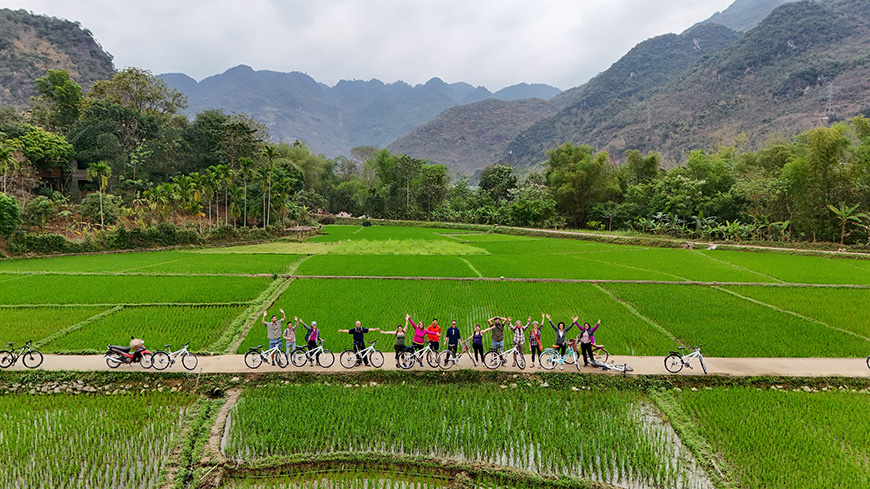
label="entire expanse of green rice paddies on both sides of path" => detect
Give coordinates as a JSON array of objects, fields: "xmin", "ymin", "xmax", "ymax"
[{"xmin": 0, "ymin": 226, "xmax": 870, "ymax": 489}]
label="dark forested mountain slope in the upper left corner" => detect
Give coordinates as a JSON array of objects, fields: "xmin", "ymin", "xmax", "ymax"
[{"xmin": 0, "ymin": 9, "xmax": 115, "ymax": 109}]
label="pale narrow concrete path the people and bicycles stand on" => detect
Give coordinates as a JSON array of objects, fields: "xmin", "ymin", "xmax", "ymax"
[{"xmin": 10, "ymin": 353, "xmax": 870, "ymax": 378}]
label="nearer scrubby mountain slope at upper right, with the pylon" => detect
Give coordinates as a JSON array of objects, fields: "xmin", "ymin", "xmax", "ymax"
[{"xmin": 501, "ymin": 0, "xmax": 870, "ymax": 167}]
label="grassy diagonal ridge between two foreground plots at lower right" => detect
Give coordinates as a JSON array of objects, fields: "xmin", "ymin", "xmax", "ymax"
[{"xmin": 647, "ymin": 388, "xmax": 738, "ymax": 489}]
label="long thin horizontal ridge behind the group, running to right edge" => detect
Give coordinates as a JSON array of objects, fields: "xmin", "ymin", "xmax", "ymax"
[{"xmin": 290, "ymin": 275, "xmax": 870, "ymax": 288}]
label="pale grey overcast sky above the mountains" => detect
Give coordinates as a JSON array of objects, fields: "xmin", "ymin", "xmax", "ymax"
[{"xmin": 11, "ymin": 0, "xmax": 733, "ymax": 91}]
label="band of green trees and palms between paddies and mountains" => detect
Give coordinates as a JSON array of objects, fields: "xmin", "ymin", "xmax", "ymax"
[{"xmin": 0, "ymin": 68, "xmax": 870, "ymax": 244}]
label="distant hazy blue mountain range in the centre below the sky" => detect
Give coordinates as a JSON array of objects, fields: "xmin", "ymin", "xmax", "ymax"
[{"xmin": 159, "ymin": 65, "xmax": 561, "ymax": 157}]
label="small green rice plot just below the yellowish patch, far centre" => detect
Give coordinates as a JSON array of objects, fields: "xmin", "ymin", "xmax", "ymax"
[{"xmin": 296, "ymin": 255, "xmax": 477, "ymax": 277}]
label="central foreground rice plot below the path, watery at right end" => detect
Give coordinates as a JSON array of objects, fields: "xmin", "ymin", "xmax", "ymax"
[{"xmin": 225, "ymin": 384, "xmax": 708, "ymax": 487}]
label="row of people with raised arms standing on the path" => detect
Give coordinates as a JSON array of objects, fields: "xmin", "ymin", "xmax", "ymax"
[{"xmin": 263, "ymin": 309, "xmax": 601, "ymax": 368}]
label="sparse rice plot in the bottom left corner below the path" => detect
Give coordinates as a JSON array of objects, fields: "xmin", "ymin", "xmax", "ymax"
[{"xmin": 0, "ymin": 393, "xmax": 194, "ymax": 488}]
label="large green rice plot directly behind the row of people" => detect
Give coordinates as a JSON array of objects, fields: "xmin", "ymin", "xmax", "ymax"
[{"xmin": 238, "ymin": 279, "xmax": 674, "ymax": 355}]
